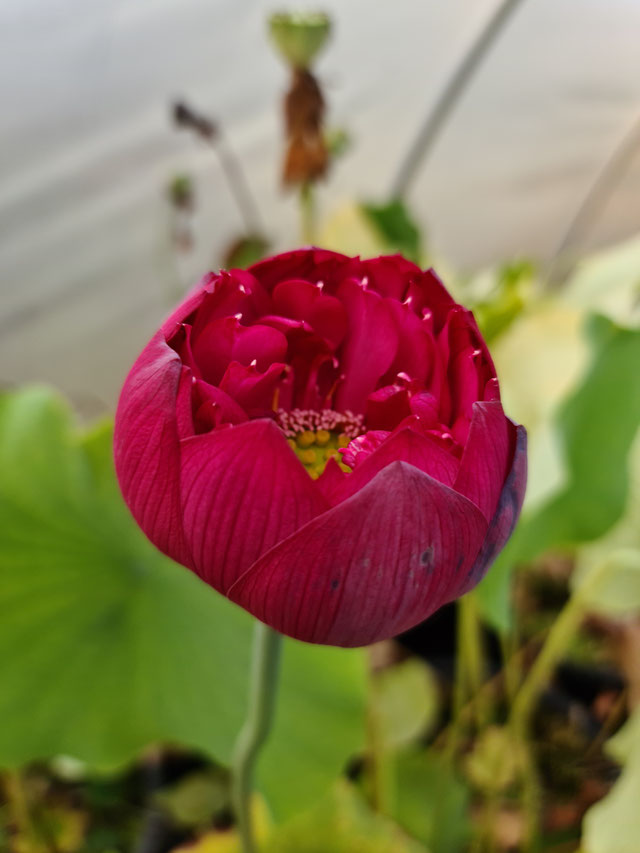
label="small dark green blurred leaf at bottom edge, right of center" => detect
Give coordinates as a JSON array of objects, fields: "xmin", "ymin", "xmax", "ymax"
[{"xmin": 394, "ymin": 751, "xmax": 471, "ymax": 853}]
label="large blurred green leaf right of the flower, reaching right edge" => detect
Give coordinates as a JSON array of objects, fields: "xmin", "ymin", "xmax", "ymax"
[{"xmin": 478, "ymin": 317, "xmax": 640, "ymax": 628}]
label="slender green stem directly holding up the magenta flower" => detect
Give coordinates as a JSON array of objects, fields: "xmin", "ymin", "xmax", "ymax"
[{"xmin": 231, "ymin": 622, "xmax": 282, "ymax": 853}]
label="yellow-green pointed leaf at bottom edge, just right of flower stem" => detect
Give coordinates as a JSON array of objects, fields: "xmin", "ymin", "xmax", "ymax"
[{"xmin": 263, "ymin": 782, "xmax": 427, "ymax": 853}]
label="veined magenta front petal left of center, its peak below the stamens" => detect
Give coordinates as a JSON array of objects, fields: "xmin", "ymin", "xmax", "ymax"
[{"xmin": 181, "ymin": 419, "xmax": 328, "ymax": 593}]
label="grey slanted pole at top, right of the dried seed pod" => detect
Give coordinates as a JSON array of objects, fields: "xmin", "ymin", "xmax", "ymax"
[{"xmin": 391, "ymin": 0, "xmax": 522, "ymax": 198}]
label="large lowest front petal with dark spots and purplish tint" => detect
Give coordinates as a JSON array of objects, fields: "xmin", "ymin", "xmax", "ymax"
[{"xmin": 228, "ymin": 462, "xmax": 487, "ymax": 646}]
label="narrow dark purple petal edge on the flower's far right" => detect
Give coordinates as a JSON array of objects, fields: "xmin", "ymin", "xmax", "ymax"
[{"xmin": 460, "ymin": 426, "xmax": 527, "ymax": 595}]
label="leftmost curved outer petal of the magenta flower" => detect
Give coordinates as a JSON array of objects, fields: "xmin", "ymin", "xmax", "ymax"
[{"xmin": 114, "ymin": 332, "xmax": 192, "ymax": 566}]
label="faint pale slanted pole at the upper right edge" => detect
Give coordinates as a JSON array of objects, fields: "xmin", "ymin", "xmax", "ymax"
[{"xmin": 547, "ymin": 111, "xmax": 640, "ymax": 286}]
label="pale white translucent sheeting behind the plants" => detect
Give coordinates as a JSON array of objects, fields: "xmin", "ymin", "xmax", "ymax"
[{"xmin": 0, "ymin": 0, "xmax": 640, "ymax": 412}]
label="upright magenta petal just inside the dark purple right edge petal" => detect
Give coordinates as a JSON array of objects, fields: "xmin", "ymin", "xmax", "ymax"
[{"xmin": 454, "ymin": 400, "xmax": 515, "ymax": 521}]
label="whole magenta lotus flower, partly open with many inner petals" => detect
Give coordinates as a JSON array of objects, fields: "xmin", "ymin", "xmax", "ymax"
[{"xmin": 115, "ymin": 249, "xmax": 526, "ymax": 646}]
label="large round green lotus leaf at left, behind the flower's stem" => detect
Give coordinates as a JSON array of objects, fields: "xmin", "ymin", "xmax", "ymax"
[{"xmin": 0, "ymin": 389, "xmax": 365, "ymax": 814}]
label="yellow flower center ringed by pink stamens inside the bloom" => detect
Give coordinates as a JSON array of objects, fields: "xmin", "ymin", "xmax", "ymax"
[{"xmin": 276, "ymin": 409, "xmax": 365, "ymax": 480}]
